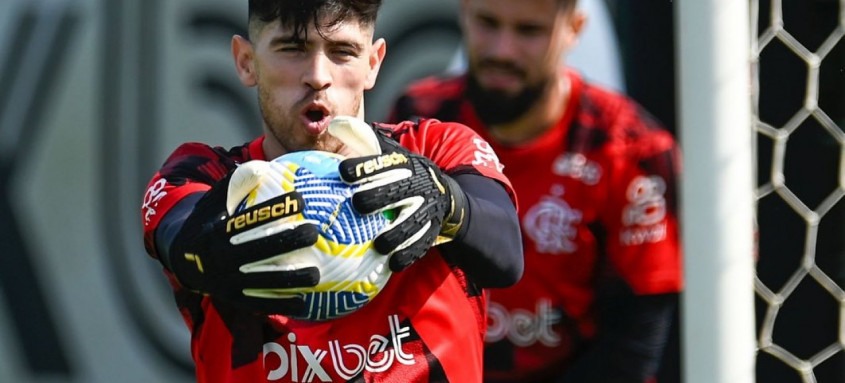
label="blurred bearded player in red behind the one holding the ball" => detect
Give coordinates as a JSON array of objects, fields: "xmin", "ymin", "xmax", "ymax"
[{"xmin": 391, "ymin": 0, "xmax": 682, "ymax": 383}]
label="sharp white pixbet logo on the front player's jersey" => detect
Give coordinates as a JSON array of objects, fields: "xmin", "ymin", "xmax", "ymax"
[{"xmin": 264, "ymin": 315, "xmax": 415, "ymax": 382}]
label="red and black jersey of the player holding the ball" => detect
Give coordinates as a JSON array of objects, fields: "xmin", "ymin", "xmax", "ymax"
[{"xmin": 142, "ymin": 120, "xmax": 513, "ymax": 383}]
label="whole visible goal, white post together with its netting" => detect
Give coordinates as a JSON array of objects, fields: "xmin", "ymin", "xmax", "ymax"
[{"xmin": 676, "ymin": 0, "xmax": 845, "ymax": 383}]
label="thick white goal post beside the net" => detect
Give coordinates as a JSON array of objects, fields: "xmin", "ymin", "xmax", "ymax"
[{"xmin": 675, "ymin": 0, "xmax": 756, "ymax": 383}]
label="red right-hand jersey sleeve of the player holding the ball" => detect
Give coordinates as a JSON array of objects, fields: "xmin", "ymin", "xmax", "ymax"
[{"xmin": 390, "ymin": 119, "xmax": 516, "ymax": 210}]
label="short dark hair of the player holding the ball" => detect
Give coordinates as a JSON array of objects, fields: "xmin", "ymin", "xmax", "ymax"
[{"xmin": 248, "ymin": 0, "xmax": 382, "ymax": 40}]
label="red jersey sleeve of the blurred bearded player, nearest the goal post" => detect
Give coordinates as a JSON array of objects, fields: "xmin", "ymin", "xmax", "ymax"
[{"xmin": 603, "ymin": 103, "xmax": 683, "ymax": 295}]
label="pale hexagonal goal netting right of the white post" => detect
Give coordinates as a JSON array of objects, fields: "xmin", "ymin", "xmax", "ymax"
[{"xmin": 750, "ymin": 0, "xmax": 845, "ymax": 383}]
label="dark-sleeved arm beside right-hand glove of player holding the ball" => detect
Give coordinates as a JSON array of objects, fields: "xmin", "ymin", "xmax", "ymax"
[{"xmin": 441, "ymin": 174, "xmax": 523, "ymax": 287}]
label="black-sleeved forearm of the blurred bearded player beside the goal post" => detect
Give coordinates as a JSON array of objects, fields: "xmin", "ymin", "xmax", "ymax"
[{"xmin": 559, "ymin": 294, "xmax": 678, "ymax": 383}]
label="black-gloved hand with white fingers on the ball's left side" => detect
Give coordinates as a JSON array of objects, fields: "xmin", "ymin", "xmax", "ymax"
[{"xmin": 169, "ymin": 161, "xmax": 320, "ymax": 315}]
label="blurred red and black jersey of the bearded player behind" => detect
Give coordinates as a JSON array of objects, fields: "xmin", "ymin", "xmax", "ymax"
[{"xmin": 391, "ymin": 70, "xmax": 682, "ymax": 382}]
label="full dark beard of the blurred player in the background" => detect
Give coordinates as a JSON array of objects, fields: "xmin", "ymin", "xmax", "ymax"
[{"xmin": 467, "ymin": 65, "xmax": 549, "ymax": 127}]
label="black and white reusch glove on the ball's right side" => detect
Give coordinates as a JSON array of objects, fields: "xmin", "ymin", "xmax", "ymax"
[{"xmin": 340, "ymin": 132, "xmax": 466, "ymax": 271}]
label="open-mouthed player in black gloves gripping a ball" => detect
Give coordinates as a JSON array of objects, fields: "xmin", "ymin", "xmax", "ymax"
[{"xmin": 141, "ymin": 0, "xmax": 522, "ymax": 382}]
